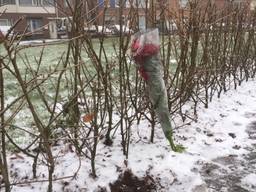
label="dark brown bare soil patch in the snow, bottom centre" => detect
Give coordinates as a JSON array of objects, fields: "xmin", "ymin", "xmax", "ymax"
[{"xmin": 109, "ymin": 170, "xmax": 157, "ymax": 192}]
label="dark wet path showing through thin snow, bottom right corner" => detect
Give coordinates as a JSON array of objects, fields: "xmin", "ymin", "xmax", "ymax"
[{"xmin": 194, "ymin": 118, "xmax": 256, "ymax": 192}]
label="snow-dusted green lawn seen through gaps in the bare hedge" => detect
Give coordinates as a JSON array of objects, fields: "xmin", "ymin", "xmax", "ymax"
[{"xmin": 0, "ymin": 38, "xmax": 178, "ymax": 142}]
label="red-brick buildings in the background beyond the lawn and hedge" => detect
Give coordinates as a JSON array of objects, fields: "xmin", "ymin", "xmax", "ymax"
[{"xmin": 4, "ymin": 0, "xmax": 256, "ymax": 38}]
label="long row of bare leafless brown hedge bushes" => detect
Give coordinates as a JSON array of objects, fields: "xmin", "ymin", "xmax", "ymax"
[{"xmin": 0, "ymin": 0, "xmax": 256, "ymax": 192}]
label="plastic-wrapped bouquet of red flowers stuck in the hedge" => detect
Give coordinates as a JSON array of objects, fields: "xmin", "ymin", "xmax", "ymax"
[{"xmin": 131, "ymin": 29, "xmax": 185, "ymax": 152}]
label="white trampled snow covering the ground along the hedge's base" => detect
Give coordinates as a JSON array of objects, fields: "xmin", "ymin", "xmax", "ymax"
[{"xmin": 3, "ymin": 81, "xmax": 256, "ymax": 192}]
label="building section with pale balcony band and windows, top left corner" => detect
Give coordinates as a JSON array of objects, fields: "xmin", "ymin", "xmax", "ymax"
[{"xmin": 0, "ymin": 0, "xmax": 56, "ymax": 38}]
